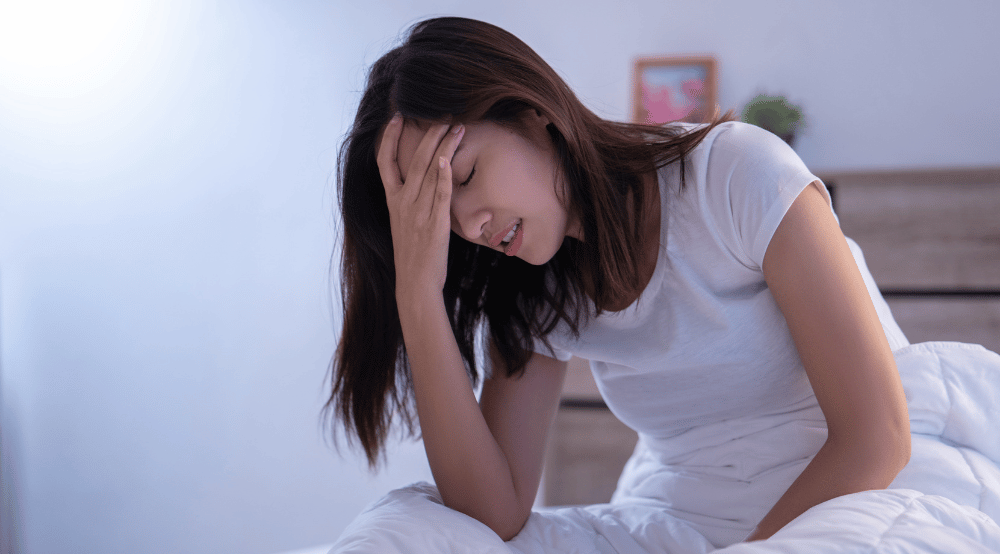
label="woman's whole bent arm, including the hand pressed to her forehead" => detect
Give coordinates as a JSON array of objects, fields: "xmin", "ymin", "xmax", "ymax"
[{"xmin": 377, "ymin": 117, "xmax": 566, "ymax": 540}]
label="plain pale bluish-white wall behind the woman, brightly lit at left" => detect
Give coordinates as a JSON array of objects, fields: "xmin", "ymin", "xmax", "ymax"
[{"xmin": 0, "ymin": 0, "xmax": 1000, "ymax": 554}]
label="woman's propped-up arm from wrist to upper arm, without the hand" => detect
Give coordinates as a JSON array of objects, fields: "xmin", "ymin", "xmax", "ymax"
[{"xmin": 400, "ymin": 294, "xmax": 566, "ymax": 540}]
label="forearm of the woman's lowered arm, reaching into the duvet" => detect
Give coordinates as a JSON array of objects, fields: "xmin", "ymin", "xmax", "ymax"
[{"xmin": 746, "ymin": 432, "xmax": 909, "ymax": 541}]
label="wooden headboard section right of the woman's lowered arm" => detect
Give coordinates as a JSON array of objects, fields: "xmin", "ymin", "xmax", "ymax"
[{"xmin": 819, "ymin": 168, "xmax": 1000, "ymax": 352}]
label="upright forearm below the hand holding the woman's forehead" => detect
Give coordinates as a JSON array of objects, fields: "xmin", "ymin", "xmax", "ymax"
[{"xmin": 399, "ymin": 294, "xmax": 524, "ymax": 539}]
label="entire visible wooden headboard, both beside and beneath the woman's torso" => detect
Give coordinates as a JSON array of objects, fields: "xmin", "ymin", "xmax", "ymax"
[{"xmin": 540, "ymin": 167, "xmax": 1000, "ymax": 506}]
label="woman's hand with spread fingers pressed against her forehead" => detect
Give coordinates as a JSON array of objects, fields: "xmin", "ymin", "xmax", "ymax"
[{"xmin": 377, "ymin": 115, "xmax": 465, "ymax": 298}]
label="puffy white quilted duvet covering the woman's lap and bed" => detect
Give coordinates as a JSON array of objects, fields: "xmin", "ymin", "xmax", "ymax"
[{"xmin": 331, "ymin": 342, "xmax": 1000, "ymax": 554}]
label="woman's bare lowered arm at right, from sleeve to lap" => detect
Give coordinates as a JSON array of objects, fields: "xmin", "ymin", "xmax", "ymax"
[{"xmin": 747, "ymin": 182, "xmax": 910, "ymax": 540}]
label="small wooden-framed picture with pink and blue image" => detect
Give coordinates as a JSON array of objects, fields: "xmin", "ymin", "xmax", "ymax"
[{"xmin": 632, "ymin": 56, "xmax": 718, "ymax": 125}]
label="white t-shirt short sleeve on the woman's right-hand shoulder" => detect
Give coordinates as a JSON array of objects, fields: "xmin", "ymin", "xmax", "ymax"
[{"xmin": 706, "ymin": 122, "xmax": 840, "ymax": 270}]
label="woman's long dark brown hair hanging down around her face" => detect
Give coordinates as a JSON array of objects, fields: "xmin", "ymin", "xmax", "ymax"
[{"xmin": 323, "ymin": 17, "xmax": 732, "ymax": 467}]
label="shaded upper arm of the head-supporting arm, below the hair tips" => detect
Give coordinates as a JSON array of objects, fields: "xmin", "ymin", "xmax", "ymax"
[{"xmin": 479, "ymin": 341, "xmax": 567, "ymax": 518}]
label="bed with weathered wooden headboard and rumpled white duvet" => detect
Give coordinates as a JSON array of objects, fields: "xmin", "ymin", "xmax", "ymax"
[{"xmin": 324, "ymin": 168, "xmax": 1000, "ymax": 554}]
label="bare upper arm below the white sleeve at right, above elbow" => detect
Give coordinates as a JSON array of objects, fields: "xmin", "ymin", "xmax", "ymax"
[{"xmin": 762, "ymin": 181, "xmax": 909, "ymax": 463}]
